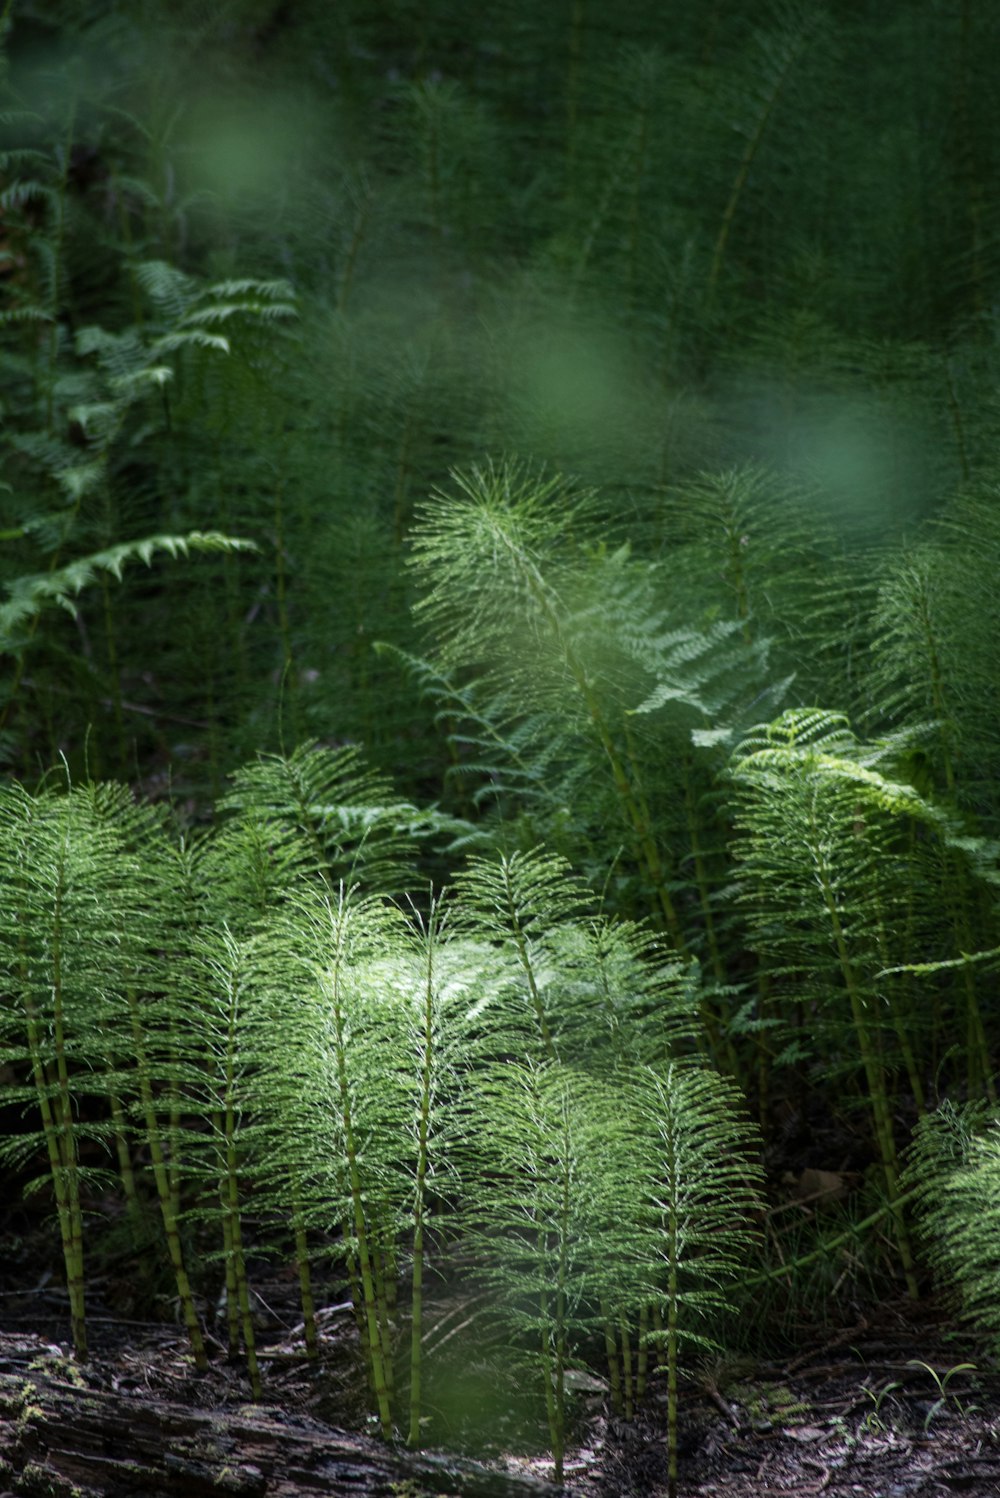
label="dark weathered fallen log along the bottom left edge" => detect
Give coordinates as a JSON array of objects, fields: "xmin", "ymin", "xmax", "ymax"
[{"xmin": 0, "ymin": 1333, "xmax": 558, "ymax": 1498}]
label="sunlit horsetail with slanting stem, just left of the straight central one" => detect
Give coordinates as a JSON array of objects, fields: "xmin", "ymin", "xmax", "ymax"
[{"xmin": 248, "ymin": 885, "xmax": 409, "ymax": 1438}]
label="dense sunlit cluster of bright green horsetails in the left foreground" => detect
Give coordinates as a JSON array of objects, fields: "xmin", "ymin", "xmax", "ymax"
[{"xmin": 0, "ymin": 749, "xmax": 759, "ymax": 1471}]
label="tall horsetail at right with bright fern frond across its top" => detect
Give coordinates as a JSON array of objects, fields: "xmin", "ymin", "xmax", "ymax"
[{"xmin": 732, "ymin": 710, "xmax": 990, "ymax": 1296}]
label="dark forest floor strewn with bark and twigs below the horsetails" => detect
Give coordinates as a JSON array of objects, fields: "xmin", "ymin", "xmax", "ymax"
[{"xmin": 0, "ymin": 1261, "xmax": 1000, "ymax": 1498}]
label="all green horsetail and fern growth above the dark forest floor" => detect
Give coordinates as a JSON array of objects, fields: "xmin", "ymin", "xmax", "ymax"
[{"xmin": 0, "ymin": 0, "xmax": 1000, "ymax": 1479}]
